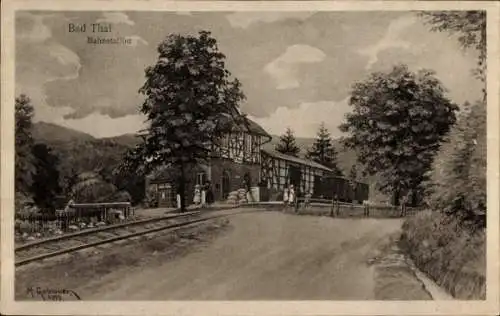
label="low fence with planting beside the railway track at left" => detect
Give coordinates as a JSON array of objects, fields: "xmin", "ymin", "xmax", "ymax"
[{"xmin": 15, "ymin": 202, "xmax": 134, "ymax": 235}]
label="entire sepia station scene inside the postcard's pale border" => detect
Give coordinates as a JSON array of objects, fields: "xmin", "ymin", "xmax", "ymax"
[{"xmin": 8, "ymin": 10, "xmax": 487, "ymax": 301}]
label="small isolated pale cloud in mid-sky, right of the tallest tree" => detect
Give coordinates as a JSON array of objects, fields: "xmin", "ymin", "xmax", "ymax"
[{"xmin": 264, "ymin": 45, "xmax": 326, "ymax": 90}]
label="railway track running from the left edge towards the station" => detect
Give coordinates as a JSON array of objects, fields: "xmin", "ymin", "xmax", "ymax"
[{"xmin": 15, "ymin": 210, "xmax": 255, "ymax": 267}]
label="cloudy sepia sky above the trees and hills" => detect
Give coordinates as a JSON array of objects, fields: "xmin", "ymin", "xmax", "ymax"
[{"xmin": 15, "ymin": 11, "xmax": 481, "ymax": 137}]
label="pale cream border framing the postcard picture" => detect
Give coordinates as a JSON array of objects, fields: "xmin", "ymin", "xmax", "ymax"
[{"xmin": 0, "ymin": 0, "xmax": 500, "ymax": 315}]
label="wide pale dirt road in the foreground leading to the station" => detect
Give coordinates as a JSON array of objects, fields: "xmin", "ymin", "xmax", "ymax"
[{"xmin": 81, "ymin": 212, "xmax": 430, "ymax": 300}]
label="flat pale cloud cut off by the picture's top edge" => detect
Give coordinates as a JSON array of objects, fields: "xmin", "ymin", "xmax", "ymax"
[{"xmin": 226, "ymin": 12, "xmax": 314, "ymax": 29}]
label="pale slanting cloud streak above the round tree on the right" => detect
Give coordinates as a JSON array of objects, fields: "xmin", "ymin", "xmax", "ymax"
[{"xmin": 358, "ymin": 15, "xmax": 417, "ymax": 70}]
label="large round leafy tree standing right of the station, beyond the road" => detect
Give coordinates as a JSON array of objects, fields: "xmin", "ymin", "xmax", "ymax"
[{"xmin": 339, "ymin": 65, "xmax": 458, "ymax": 204}]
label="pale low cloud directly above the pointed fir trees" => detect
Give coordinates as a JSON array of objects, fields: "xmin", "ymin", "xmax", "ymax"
[{"xmin": 248, "ymin": 99, "xmax": 349, "ymax": 138}]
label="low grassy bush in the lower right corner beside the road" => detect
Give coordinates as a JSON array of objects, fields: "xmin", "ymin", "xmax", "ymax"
[{"xmin": 401, "ymin": 211, "xmax": 486, "ymax": 299}]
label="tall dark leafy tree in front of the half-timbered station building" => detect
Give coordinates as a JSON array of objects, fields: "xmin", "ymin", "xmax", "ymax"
[{"xmin": 122, "ymin": 31, "xmax": 244, "ymax": 210}]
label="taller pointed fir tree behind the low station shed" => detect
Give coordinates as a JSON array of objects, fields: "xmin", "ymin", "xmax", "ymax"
[{"xmin": 306, "ymin": 122, "xmax": 342, "ymax": 176}]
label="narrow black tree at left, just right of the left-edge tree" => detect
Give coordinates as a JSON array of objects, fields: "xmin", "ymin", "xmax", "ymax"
[{"xmin": 31, "ymin": 144, "xmax": 61, "ymax": 211}]
